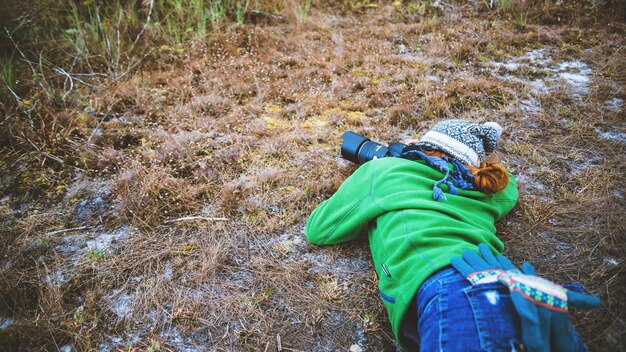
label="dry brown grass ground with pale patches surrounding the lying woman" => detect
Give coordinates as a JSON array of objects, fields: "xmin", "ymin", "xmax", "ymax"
[{"xmin": 0, "ymin": 1, "xmax": 626, "ymax": 351}]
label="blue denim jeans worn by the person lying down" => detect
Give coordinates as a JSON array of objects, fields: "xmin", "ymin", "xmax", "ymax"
[{"xmin": 408, "ymin": 268, "xmax": 587, "ymax": 352}]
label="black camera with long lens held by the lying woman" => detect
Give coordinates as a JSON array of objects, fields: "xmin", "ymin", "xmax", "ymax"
[{"xmin": 341, "ymin": 131, "xmax": 407, "ymax": 165}]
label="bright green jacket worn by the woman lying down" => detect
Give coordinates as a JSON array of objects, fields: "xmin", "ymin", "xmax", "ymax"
[{"xmin": 305, "ymin": 158, "xmax": 518, "ymax": 350}]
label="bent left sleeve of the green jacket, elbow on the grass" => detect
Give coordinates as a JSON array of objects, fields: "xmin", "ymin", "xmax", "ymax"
[{"xmin": 305, "ymin": 160, "xmax": 385, "ymax": 245}]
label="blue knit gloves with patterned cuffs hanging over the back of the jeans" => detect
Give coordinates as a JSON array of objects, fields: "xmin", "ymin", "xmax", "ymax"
[{"xmin": 450, "ymin": 243, "xmax": 600, "ymax": 352}]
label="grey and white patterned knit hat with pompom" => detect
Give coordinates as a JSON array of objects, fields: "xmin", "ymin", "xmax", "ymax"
[{"xmin": 415, "ymin": 120, "xmax": 502, "ymax": 167}]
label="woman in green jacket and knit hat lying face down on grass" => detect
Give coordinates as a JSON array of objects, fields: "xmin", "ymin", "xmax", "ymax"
[{"xmin": 306, "ymin": 120, "xmax": 599, "ymax": 351}]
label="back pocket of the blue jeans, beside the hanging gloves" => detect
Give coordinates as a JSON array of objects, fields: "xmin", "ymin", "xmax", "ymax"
[{"xmin": 463, "ymin": 282, "xmax": 521, "ymax": 351}]
